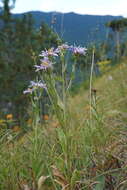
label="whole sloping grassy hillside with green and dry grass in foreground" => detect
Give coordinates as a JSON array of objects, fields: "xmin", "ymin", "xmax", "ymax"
[{"xmin": 0, "ymin": 60, "xmax": 127, "ymax": 190}]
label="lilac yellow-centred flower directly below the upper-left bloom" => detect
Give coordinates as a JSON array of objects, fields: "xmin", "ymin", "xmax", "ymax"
[{"xmin": 34, "ymin": 57, "xmax": 53, "ymax": 72}]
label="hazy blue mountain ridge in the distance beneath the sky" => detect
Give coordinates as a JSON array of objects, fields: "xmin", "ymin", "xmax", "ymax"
[{"xmin": 14, "ymin": 11, "xmax": 123, "ymax": 45}]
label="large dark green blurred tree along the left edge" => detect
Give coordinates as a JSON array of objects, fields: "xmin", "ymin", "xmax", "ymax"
[{"xmin": 0, "ymin": 0, "xmax": 58, "ymax": 117}]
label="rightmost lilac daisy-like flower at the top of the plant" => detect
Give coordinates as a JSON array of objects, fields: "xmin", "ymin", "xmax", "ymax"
[{"xmin": 69, "ymin": 46, "xmax": 87, "ymax": 55}]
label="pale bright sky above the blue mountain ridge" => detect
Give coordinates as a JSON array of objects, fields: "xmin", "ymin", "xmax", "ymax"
[{"xmin": 13, "ymin": 0, "xmax": 127, "ymax": 17}]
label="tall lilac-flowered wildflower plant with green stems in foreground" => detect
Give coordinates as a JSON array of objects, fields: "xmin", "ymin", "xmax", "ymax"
[{"xmin": 24, "ymin": 43, "xmax": 86, "ymax": 188}]
